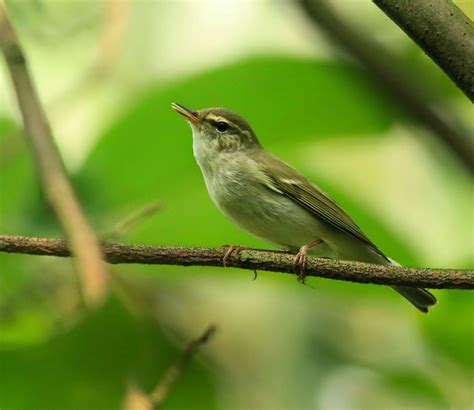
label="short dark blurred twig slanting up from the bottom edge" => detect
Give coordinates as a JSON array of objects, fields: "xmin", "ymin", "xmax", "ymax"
[{"xmin": 150, "ymin": 325, "xmax": 216, "ymax": 408}]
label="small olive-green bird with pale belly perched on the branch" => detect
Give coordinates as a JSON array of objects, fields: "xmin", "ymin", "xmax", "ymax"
[{"xmin": 171, "ymin": 103, "xmax": 437, "ymax": 313}]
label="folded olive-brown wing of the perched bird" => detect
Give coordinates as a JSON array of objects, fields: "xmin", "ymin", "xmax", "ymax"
[{"xmin": 260, "ymin": 154, "xmax": 386, "ymax": 258}]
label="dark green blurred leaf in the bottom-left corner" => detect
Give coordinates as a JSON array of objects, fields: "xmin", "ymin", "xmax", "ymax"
[{"xmin": 0, "ymin": 299, "xmax": 215, "ymax": 410}]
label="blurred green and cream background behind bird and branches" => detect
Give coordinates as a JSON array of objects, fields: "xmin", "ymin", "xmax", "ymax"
[{"xmin": 0, "ymin": 0, "xmax": 474, "ymax": 410}]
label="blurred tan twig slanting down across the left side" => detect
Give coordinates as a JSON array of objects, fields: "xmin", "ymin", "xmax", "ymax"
[{"xmin": 0, "ymin": 5, "xmax": 107, "ymax": 306}]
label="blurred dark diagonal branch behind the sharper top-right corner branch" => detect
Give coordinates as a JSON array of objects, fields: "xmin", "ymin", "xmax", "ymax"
[{"xmin": 299, "ymin": 0, "xmax": 474, "ymax": 173}]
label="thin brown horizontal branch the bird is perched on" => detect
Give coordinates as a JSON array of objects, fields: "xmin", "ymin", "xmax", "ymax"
[{"xmin": 0, "ymin": 235, "xmax": 474, "ymax": 289}]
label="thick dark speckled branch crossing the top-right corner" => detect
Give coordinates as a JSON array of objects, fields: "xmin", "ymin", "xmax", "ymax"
[{"xmin": 373, "ymin": 0, "xmax": 474, "ymax": 102}]
